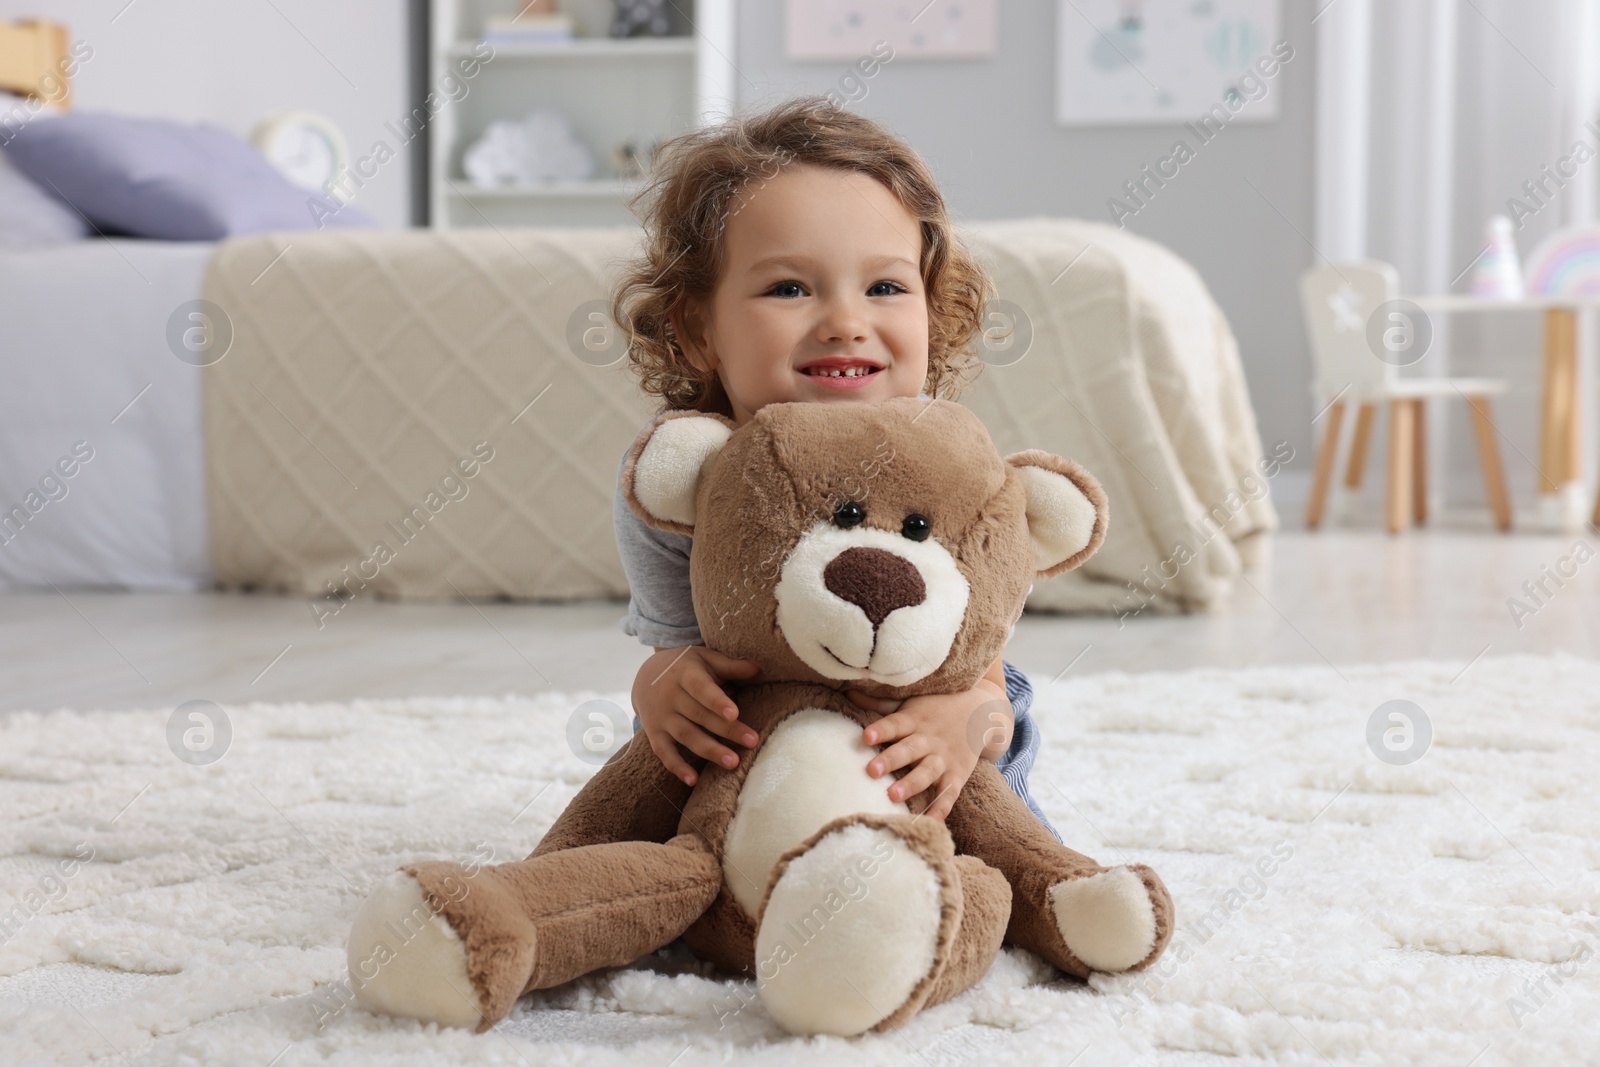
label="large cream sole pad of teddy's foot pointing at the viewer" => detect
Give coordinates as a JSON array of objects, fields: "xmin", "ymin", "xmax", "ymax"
[{"xmin": 755, "ymin": 822, "xmax": 947, "ymax": 1037}]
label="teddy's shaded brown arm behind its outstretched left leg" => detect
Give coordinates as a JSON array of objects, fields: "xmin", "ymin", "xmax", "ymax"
[{"xmin": 533, "ymin": 731, "xmax": 690, "ymax": 856}]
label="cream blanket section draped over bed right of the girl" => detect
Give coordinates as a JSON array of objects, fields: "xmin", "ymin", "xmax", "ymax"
[{"xmin": 962, "ymin": 218, "xmax": 1293, "ymax": 614}]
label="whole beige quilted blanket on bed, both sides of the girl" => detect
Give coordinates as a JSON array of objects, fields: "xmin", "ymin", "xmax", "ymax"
[{"xmin": 203, "ymin": 219, "xmax": 1275, "ymax": 622}]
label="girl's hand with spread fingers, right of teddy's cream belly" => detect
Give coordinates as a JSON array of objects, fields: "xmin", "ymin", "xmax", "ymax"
[{"xmin": 845, "ymin": 678, "xmax": 1011, "ymax": 819}]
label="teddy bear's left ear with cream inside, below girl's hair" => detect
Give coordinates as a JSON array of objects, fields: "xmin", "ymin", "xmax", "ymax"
[{"xmin": 622, "ymin": 411, "xmax": 734, "ymax": 534}]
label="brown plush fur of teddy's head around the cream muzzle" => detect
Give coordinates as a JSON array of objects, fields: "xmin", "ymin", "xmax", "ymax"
[{"xmin": 636, "ymin": 398, "xmax": 1036, "ymax": 697}]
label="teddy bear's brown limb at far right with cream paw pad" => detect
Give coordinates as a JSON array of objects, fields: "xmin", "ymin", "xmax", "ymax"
[{"xmin": 946, "ymin": 761, "xmax": 1173, "ymax": 977}]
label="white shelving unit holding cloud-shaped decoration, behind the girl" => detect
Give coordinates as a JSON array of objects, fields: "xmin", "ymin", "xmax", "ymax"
[{"xmin": 429, "ymin": 0, "xmax": 736, "ymax": 229}]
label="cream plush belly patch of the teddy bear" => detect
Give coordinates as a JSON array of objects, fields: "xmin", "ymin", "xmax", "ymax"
[{"xmin": 722, "ymin": 707, "xmax": 909, "ymax": 918}]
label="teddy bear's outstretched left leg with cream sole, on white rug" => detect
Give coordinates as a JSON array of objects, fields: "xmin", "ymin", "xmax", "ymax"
[{"xmin": 349, "ymin": 833, "xmax": 722, "ymax": 1030}]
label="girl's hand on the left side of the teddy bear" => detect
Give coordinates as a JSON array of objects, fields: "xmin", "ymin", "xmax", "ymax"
[{"xmin": 632, "ymin": 645, "xmax": 760, "ymax": 785}]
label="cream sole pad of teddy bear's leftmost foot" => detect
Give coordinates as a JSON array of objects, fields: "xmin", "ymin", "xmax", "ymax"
[{"xmin": 349, "ymin": 870, "xmax": 482, "ymax": 1027}]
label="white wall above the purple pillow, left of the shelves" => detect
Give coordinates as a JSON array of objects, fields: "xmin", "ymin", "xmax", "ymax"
[{"xmin": 0, "ymin": 0, "xmax": 411, "ymax": 226}]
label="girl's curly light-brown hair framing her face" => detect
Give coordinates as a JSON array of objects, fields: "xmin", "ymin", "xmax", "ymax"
[{"xmin": 611, "ymin": 96, "xmax": 994, "ymax": 416}]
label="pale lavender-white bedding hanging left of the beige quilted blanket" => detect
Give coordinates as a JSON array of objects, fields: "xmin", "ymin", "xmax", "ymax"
[{"xmin": 0, "ymin": 238, "xmax": 213, "ymax": 590}]
